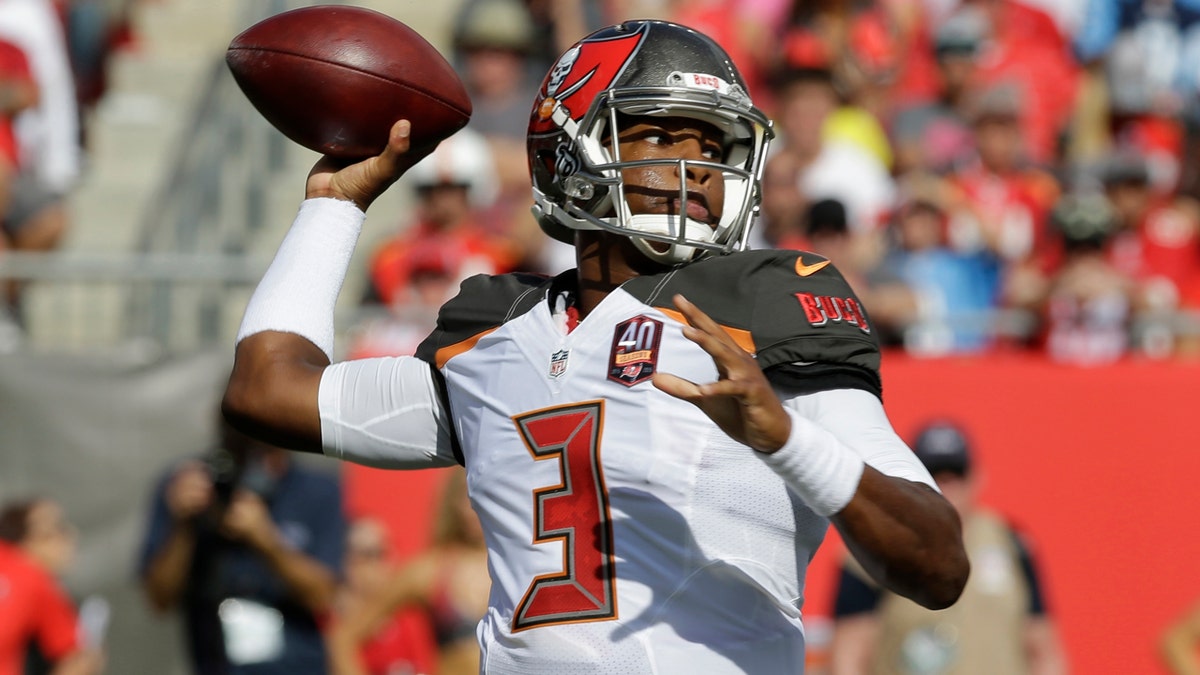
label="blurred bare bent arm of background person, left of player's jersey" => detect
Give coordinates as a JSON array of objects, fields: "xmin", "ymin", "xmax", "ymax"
[{"xmin": 325, "ymin": 554, "xmax": 438, "ymax": 675}]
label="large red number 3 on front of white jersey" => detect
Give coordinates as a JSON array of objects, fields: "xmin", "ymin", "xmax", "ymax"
[{"xmin": 512, "ymin": 401, "xmax": 617, "ymax": 633}]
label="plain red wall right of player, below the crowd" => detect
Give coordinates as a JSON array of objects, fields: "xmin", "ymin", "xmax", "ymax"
[{"xmin": 805, "ymin": 353, "xmax": 1200, "ymax": 674}]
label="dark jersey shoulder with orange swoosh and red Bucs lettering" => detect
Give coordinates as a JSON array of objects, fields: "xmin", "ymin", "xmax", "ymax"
[{"xmin": 623, "ymin": 250, "xmax": 880, "ymax": 380}]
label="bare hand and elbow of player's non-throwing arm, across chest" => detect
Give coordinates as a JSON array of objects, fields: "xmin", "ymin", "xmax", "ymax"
[{"xmin": 654, "ymin": 295, "xmax": 970, "ymax": 609}]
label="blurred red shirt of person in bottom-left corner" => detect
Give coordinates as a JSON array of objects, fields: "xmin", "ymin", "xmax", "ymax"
[{"xmin": 0, "ymin": 542, "xmax": 78, "ymax": 675}]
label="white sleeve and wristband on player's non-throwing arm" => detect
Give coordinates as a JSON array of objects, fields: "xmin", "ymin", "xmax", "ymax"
[{"xmin": 760, "ymin": 389, "xmax": 937, "ymax": 516}]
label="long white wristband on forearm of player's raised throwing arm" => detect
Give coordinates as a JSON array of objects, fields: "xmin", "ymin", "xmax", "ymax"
[{"xmin": 238, "ymin": 197, "xmax": 366, "ymax": 360}]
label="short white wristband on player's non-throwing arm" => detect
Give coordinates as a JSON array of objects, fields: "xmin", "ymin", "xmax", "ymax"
[{"xmin": 756, "ymin": 410, "xmax": 866, "ymax": 516}]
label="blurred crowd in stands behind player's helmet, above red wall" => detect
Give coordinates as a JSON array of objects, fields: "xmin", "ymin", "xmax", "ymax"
[{"xmin": 354, "ymin": 0, "xmax": 1200, "ymax": 364}]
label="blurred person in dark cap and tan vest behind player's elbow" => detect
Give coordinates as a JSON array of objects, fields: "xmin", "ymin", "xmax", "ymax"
[{"xmin": 832, "ymin": 419, "xmax": 1067, "ymax": 675}]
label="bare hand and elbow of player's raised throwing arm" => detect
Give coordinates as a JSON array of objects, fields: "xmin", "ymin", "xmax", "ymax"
[{"xmin": 221, "ymin": 120, "xmax": 421, "ymax": 453}]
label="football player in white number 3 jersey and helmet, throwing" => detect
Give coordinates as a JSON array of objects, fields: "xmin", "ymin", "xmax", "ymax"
[{"xmin": 223, "ymin": 20, "xmax": 968, "ymax": 674}]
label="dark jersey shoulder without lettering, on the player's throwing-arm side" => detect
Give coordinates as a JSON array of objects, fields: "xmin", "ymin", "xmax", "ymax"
[{"xmin": 416, "ymin": 273, "xmax": 553, "ymax": 365}]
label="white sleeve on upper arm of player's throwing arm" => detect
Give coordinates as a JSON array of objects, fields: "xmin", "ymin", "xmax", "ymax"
[{"xmin": 318, "ymin": 357, "xmax": 457, "ymax": 468}]
